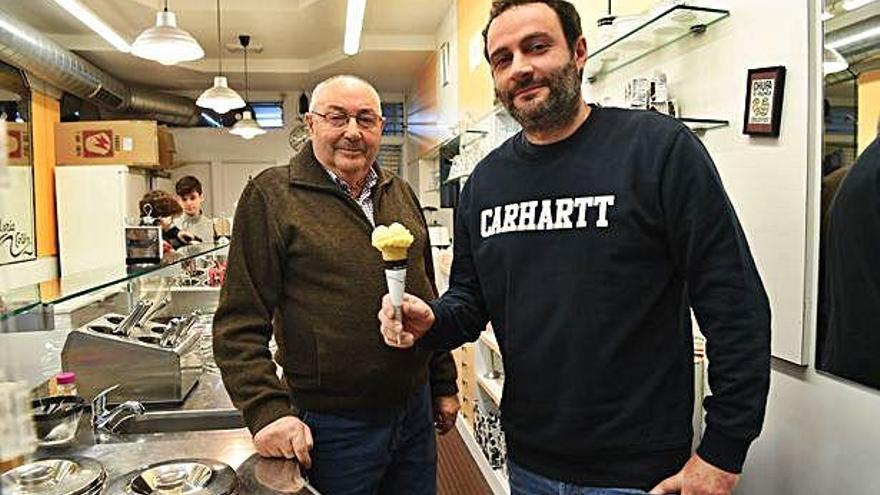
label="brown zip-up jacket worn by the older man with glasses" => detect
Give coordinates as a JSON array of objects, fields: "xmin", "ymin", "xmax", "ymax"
[{"xmin": 214, "ymin": 145, "xmax": 457, "ymax": 434}]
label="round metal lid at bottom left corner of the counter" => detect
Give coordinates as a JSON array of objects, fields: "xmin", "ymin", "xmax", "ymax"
[{"xmin": 0, "ymin": 457, "xmax": 107, "ymax": 495}]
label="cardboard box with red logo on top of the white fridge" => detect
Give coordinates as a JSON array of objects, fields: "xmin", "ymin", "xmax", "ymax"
[{"xmin": 55, "ymin": 120, "xmax": 174, "ymax": 168}]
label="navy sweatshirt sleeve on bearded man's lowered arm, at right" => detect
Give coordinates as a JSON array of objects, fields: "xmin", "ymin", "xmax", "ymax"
[{"xmin": 660, "ymin": 129, "xmax": 770, "ymax": 473}]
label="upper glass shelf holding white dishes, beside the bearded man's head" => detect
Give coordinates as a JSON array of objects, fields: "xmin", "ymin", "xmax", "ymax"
[{"xmin": 587, "ymin": 5, "xmax": 730, "ymax": 79}]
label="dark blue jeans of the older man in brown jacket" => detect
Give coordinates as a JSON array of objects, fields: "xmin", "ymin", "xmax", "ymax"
[{"xmin": 302, "ymin": 386, "xmax": 437, "ymax": 495}]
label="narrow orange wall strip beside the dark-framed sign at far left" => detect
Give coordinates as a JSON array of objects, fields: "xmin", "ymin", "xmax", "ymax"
[{"xmin": 31, "ymin": 91, "xmax": 61, "ymax": 257}]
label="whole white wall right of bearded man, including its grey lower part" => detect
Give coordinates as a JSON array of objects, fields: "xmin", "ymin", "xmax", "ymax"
[{"xmin": 592, "ymin": 0, "xmax": 880, "ymax": 495}]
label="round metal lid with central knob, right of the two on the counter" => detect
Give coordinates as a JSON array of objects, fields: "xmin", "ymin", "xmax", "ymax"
[{"xmin": 107, "ymin": 459, "xmax": 238, "ymax": 495}]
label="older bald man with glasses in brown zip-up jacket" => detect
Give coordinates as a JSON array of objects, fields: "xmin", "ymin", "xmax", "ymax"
[{"xmin": 214, "ymin": 76, "xmax": 458, "ymax": 495}]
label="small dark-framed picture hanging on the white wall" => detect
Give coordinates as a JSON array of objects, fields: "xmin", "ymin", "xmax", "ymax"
[{"xmin": 743, "ymin": 66, "xmax": 785, "ymax": 137}]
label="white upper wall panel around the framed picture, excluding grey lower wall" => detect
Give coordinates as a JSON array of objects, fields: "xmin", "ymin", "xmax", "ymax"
[{"xmin": 590, "ymin": 0, "xmax": 808, "ymax": 364}]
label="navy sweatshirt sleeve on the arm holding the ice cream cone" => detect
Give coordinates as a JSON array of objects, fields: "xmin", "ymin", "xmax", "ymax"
[{"xmin": 420, "ymin": 178, "xmax": 489, "ymax": 349}]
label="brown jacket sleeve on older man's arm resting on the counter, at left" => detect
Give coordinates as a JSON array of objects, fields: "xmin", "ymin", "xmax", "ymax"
[{"xmin": 213, "ymin": 181, "xmax": 294, "ymax": 434}]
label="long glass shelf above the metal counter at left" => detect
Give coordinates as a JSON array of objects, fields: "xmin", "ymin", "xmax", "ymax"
[{"xmin": 0, "ymin": 243, "xmax": 229, "ymax": 320}]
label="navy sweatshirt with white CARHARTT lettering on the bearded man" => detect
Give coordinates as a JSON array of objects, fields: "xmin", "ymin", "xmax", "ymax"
[{"xmin": 421, "ymin": 108, "xmax": 770, "ymax": 489}]
